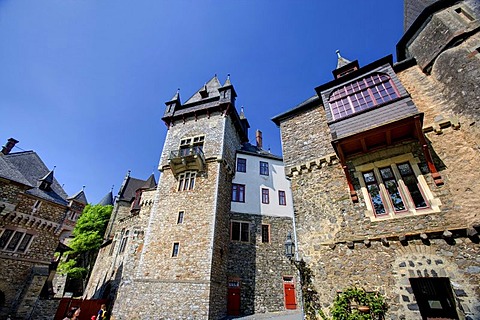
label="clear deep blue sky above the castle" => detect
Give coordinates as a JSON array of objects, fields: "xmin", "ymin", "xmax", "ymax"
[{"xmin": 0, "ymin": 0, "xmax": 403, "ymax": 203}]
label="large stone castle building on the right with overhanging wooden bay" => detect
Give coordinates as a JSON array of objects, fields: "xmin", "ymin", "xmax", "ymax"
[{"xmin": 272, "ymin": 0, "xmax": 480, "ymax": 319}]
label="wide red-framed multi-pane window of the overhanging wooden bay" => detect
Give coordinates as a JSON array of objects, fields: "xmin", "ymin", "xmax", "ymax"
[{"xmin": 328, "ymin": 73, "xmax": 398, "ymax": 120}]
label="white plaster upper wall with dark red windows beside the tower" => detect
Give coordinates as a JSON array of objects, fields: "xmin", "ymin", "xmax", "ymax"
[{"xmin": 231, "ymin": 152, "xmax": 293, "ymax": 218}]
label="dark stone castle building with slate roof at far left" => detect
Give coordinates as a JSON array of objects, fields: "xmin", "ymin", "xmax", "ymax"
[{"xmin": 0, "ymin": 138, "xmax": 87, "ymax": 319}]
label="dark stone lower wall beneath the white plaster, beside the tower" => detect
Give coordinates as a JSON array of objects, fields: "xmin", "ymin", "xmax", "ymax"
[{"xmin": 228, "ymin": 212, "xmax": 301, "ymax": 315}]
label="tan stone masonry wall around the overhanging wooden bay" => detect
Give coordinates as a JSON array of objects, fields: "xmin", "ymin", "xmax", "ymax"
[{"xmin": 281, "ymin": 57, "xmax": 480, "ymax": 319}]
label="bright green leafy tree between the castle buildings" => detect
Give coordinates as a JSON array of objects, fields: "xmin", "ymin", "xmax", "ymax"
[{"xmin": 57, "ymin": 204, "xmax": 113, "ymax": 287}]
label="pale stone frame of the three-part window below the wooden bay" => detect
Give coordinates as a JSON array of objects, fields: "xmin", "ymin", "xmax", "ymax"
[{"xmin": 354, "ymin": 153, "xmax": 442, "ymax": 221}]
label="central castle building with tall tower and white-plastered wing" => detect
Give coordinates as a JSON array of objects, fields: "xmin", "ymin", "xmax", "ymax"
[{"xmin": 86, "ymin": 76, "xmax": 300, "ymax": 319}]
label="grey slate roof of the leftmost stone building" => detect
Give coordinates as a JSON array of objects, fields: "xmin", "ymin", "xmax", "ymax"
[{"xmin": 0, "ymin": 151, "xmax": 68, "ymax": 205}]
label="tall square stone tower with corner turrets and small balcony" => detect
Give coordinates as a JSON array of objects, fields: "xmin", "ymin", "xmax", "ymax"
[{"xmin": 114, "ymin": 76, "xmax": 247, "ymax": 319}]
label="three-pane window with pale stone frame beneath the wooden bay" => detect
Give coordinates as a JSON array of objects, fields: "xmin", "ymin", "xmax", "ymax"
[{"xmin": 356, "ymin": 154, "xmax": 441, "ymax": 218}]
